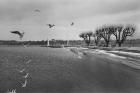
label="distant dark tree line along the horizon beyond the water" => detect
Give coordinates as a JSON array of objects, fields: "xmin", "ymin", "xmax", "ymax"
[{"xmin": 0, "ymin": 37, "xmax": 140, "ymax": 47}]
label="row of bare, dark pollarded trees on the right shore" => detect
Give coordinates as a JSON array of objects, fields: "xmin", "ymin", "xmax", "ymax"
[{"xmin": 79, "ymin": 24, "xmax": 136, "ymax": 47}]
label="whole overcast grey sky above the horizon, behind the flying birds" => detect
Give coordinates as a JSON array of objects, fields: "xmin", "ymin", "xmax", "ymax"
[{"xmin": 0, "ymin": 0, "xmax": 140, "ymax": 41}]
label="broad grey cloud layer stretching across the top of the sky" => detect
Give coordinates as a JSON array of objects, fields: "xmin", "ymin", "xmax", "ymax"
[{"xmin": 0, "ymin": 0, "xmax": 140, "ymax": 22}]
